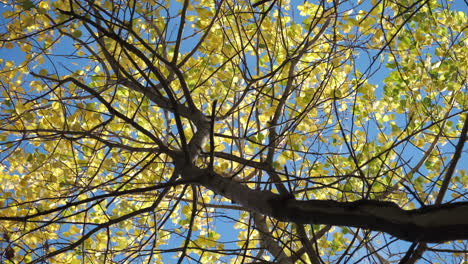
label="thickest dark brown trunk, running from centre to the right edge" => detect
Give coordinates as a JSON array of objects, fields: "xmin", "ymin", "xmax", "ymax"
[{"xmin": 181, "ymin": 167, "xmax": 468, "ymax": 243}]
